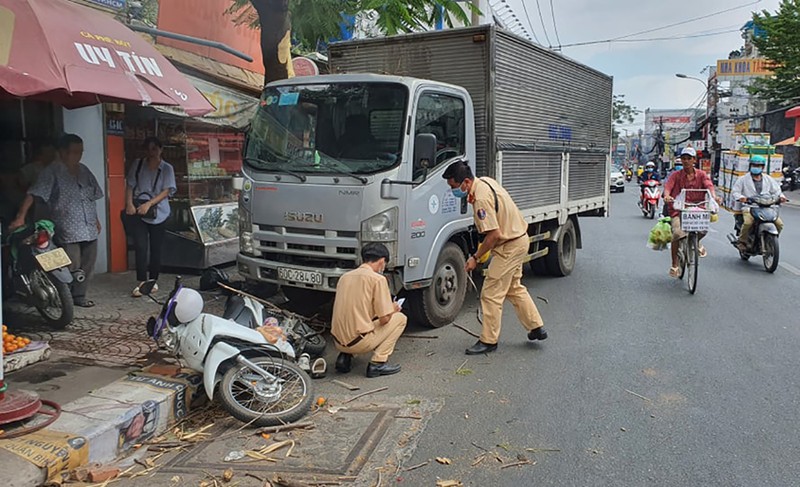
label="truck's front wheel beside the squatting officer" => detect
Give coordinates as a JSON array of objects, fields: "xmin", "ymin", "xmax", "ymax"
[{"xmin": 410, "ymin": 242, "xmax": 467, "ymax": 328}]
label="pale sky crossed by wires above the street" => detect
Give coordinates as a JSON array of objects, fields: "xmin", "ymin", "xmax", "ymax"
[{"xmin": 500, "ymin": 0, "xmax": 780, "ymax": 130}]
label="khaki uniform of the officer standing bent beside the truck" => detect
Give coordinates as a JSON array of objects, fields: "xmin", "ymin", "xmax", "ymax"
[{"xmin": 469, "ymin": 178, "xmax": 544, "ymax": 345}]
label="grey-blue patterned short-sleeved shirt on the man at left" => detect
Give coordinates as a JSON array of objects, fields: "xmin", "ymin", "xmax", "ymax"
[{"xmin": 28, "ymin": 161, "xmax": 104, "ymax": 244}]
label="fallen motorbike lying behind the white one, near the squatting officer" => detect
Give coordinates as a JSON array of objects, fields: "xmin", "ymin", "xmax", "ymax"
[{"xmin": 222, "ymin": 292, "xmax": 327, "ymax": 378}]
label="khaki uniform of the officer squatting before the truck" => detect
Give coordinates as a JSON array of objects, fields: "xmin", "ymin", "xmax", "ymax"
[{"xmin": 331, "ymin": 265, "xmax": 408, "ymax": 363}]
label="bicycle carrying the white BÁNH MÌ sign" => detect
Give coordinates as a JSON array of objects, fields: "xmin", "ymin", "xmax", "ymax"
[{"xmin": 673, "ymin": 189, "xmax": 718, "ymax": 294}]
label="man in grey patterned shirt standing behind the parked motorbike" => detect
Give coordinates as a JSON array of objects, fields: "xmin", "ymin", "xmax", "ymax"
[{"xmin": 10, "ymin": 134, "xmax": 104, "ymax": 308}]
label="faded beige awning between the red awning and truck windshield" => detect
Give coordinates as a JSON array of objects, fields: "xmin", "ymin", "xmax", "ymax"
[{"xmin": 153, "ymin": 75, "xmax": 258, "ymax": 129}]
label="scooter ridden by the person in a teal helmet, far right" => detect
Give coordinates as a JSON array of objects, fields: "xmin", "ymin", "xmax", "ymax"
[{"xmin": 728, "ymin": 197, "xmax": 780, "ymax": 273}]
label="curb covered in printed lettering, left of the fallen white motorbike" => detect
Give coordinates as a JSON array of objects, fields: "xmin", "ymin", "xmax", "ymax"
[{"xmin": 0, "ymin": 371, "xmax": 202, "ymax": 487}]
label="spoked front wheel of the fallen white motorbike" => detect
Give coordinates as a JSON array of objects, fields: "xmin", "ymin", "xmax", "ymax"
[{"xmin": 219, "ymin": 356, "xmax": 314, "ymax": 427}]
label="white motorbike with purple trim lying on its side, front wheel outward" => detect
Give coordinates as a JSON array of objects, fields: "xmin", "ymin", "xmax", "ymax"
[{"xmin": 139, "ymin": 277, "xmax": 313, "ymax": 426}]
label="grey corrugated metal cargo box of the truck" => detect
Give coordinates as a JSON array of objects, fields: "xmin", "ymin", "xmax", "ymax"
[{"xmin": 329, "ymin": 25, "xmax": 612, "ymax": 215}]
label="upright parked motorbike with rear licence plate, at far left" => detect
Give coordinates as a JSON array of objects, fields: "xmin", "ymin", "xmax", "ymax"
[{"xmin": 9, "ymin": 220, "xmax": 79, "ymax": 329}]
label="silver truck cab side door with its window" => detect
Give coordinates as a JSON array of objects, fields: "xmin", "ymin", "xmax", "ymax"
[{"xmin": 406, "ymin": 89, "xmax": 474, "ymax": 282}]
